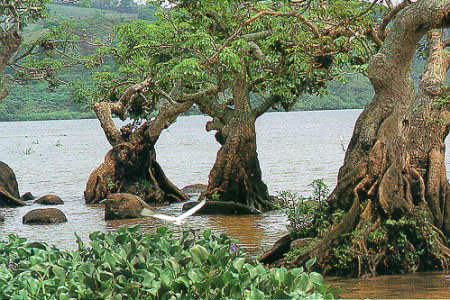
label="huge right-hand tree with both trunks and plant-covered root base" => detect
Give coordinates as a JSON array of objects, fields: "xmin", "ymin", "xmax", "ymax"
[{"xmin": 264, "ymin": 0, "xmax": 450, "ymax": 276}]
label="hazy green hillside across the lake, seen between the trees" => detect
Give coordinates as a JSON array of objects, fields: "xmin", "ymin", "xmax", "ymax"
[{"xmin": 0, "ymin": 4, "xmax": 423, "ymax": 121}]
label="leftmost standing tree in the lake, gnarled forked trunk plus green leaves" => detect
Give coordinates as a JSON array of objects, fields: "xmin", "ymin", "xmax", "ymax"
[{"xmin": 81, "ymin": 22, "xmax": 221, "ymax": 204}]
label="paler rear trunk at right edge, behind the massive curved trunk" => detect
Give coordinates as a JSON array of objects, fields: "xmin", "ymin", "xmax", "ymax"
[{"xmin": 408, "ymin": 30, "xmax": 450, "ymax": 237}]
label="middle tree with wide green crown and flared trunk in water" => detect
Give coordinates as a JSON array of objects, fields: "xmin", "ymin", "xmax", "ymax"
[{"xmin": 110, "ymin": 0, "xmax": 374, "ymax": 210}]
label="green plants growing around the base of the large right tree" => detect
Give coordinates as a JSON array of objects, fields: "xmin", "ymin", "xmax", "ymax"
[{"xmin": 278, "ymin": 179, "xmax": 450, "ymax": 276}]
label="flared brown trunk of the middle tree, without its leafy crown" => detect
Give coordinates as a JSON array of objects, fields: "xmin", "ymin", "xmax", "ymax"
[{"xmin": 204, "ymin": 78, "xmax": 273, "ymax": 211}]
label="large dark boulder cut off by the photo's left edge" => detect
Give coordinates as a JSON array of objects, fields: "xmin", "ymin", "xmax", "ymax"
[{"xmin": 0, "ymin": 161, "xmax": 27, "ymax": 207}]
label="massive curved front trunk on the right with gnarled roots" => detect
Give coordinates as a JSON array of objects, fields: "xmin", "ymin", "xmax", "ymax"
[{"xmin": 264, "ymin": 0, "xmax": 450, "ymax": 276}]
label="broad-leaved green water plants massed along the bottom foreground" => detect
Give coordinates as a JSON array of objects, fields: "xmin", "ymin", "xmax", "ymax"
[{"xmin": 0, "ymin": 227, "xmax": 336, "ymax": 299}]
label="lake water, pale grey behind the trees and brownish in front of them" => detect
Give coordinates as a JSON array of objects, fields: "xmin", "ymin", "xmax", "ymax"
[{"xmin": 0, "ymin": 110, "xmax": 450, "ymax": 298}]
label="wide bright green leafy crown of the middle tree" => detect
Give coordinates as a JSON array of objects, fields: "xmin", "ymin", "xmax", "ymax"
[{"xmin": 97, "ymin": 1, "xmax": 371, "ymax": 119}]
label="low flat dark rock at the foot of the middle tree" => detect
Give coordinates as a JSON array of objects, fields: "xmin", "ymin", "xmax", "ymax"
[{"xmin": 183, "ymin": 201, "xmax": 261, "ymax": 216}]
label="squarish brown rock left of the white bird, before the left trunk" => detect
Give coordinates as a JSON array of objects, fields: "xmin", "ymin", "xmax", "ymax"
[{"xmin": 105, "ymin": 193, "xmax": 150, "ymax": 220}]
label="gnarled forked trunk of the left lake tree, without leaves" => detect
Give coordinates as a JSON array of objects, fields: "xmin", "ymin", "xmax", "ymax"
[{"xmin": 84, "ymin": 98, "xmax": 192, "ymax": 203}]
